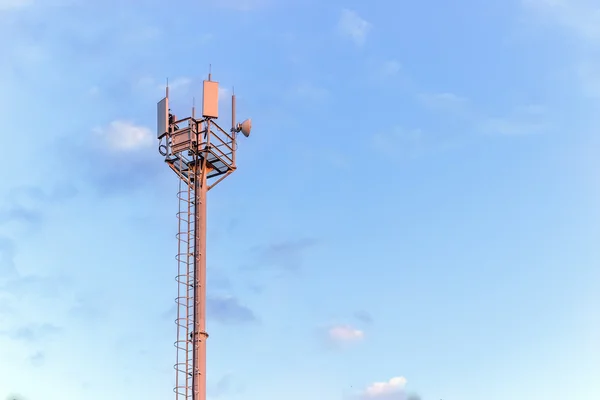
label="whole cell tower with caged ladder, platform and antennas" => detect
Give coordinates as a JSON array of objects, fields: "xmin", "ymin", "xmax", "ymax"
[{"xmin": 157, "ymin": 74, "xmax": 252, "ymax": 400}]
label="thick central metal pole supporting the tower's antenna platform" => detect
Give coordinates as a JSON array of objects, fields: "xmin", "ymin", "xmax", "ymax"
[{"xmin": 192, "ymin": 120, "xmax": 210, "ymax": 400}]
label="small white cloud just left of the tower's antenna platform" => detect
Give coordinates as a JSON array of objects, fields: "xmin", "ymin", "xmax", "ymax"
[{"xmin": 94, "ymin": 120, "xmax": 154, "ymax": 151}]
